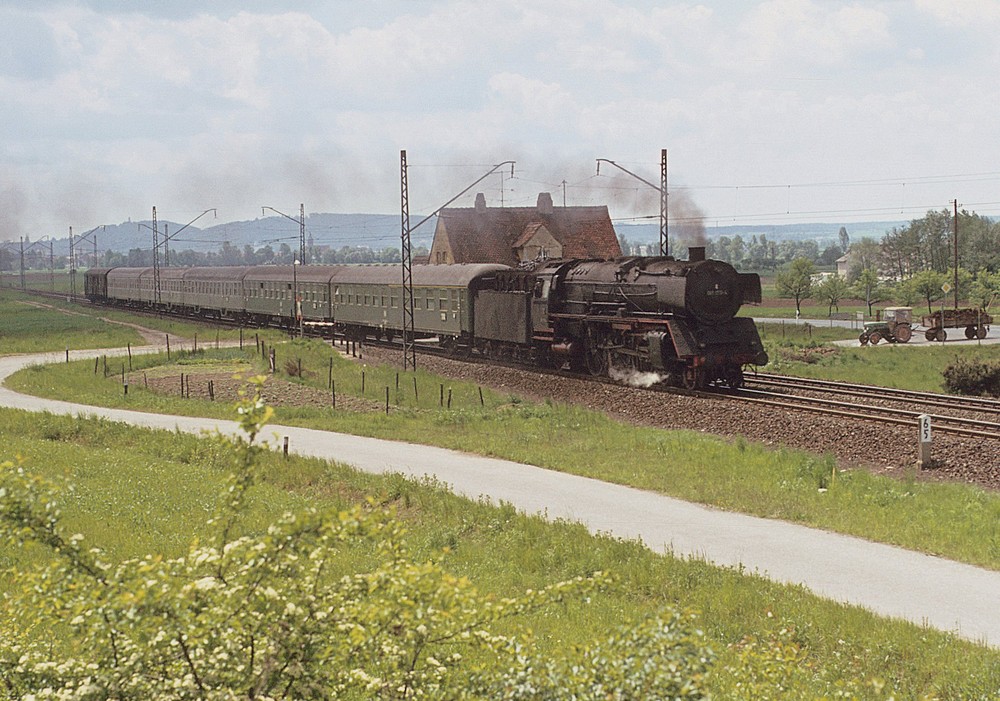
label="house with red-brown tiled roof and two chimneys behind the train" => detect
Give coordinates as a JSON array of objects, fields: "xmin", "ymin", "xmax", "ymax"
[{"xmin": 430, "ymin": 192, "xmax": 622, "ymax": 266}]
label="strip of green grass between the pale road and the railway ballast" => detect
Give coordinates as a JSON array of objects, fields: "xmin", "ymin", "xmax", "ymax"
[{"xmin": 8, "ymin": 340, "xmax": 1000, "ymax": 569}]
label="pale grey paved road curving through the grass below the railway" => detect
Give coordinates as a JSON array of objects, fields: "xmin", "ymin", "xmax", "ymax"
[{"xmin": 0, "ymin": 349, "xmax": 1000, "ymax": 648}]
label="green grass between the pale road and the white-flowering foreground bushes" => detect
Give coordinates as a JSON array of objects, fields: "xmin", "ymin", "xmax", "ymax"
[{"xmin": 0, "ymin": 410, "xmax": 1000, "ymax": 699}]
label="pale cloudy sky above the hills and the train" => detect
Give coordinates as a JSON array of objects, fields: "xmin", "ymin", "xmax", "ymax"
[{"xmin": 0, "ymin": 0, "xmax": 1000, "ymax": 240}]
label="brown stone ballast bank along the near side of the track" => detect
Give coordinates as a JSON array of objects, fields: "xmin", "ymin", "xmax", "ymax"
[{"xmin": 364, "ymin": 345, "xmax": 1000, "ymax": 490}]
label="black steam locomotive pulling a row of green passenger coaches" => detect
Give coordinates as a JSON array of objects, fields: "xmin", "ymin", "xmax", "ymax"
[{"xmin": 85, "ymin": 248, "xmax": 767, "ymax": 388}]
